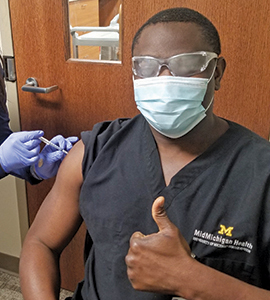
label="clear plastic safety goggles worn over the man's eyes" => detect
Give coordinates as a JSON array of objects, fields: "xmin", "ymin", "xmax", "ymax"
[{"xmin": 132, "ymin": 51, "xmax": 218, "ymax": 78}]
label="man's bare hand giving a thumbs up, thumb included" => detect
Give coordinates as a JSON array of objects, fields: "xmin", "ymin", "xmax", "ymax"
[{"xmin": 125, "ymin": 197, "xmax": 191, "ymax": 294}]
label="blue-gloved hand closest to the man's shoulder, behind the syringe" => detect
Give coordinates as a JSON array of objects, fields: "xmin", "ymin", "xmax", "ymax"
[{"xmin": 34, "ymin": 135, "xmax": 78, "ymax": 179}]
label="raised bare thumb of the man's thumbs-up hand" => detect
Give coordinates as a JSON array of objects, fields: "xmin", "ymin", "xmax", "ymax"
[{"xmin": 152, "ymin": 196, "xmax": 172, "ymax": 231}]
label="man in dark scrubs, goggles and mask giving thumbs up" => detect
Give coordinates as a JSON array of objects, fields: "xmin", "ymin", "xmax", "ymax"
[{"xmin": 20, "ymin": 8, "xmax": 270, "ymax": 300}]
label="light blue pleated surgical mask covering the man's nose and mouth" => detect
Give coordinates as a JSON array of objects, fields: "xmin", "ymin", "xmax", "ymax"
[{"xmin": 133, "ymin": 71, "xmax": 214, "ymax": 139}]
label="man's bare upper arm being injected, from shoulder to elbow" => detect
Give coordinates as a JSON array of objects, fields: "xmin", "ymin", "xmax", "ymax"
[{"xmin": 26, "ymin": 141, "xmax": 84, "ymax": 253}]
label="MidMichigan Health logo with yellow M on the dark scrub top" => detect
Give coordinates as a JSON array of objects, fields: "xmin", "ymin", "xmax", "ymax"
[{"xmin": 193, "ymin": 224, "xmax": 253, "ymax": 253}]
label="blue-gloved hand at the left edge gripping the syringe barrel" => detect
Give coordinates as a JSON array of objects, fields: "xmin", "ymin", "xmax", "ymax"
[{"xmin": 0, "ymin": 130, "xmax": 44, "ymax": 173}]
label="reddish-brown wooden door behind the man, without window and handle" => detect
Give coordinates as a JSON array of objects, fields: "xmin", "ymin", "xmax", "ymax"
[{"xmin": 10, "ymin": 0, "xmax": 270, "ymax": 290}]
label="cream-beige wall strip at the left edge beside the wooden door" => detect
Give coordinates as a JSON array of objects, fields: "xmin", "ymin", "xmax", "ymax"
[{"xmin": 0, "ymin": 0, "xmax": 28, "ymax": 257}]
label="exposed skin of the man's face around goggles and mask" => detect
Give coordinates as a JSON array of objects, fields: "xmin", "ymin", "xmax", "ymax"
[{"xmin": 133, "ymin": 22, "xmax": 224, "ymax": 107}]
